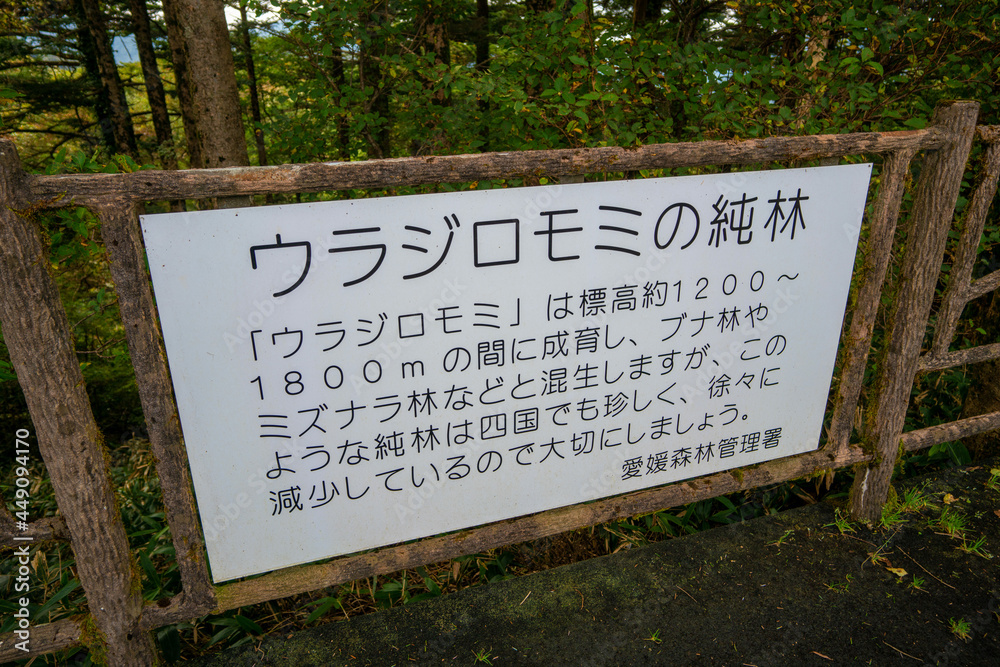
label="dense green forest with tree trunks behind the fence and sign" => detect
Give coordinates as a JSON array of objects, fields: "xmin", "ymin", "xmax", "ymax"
[{"xmin": 0, "ymin": 0, "xmax": 1000, "ymax": 657}]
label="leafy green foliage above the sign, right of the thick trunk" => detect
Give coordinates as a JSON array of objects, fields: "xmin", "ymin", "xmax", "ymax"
[{"xmin": 232, "ymin": 0, "xmax": 1000, "ymax": 162}]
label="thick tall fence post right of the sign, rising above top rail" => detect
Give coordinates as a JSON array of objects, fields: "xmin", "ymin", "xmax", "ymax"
[{"xmin": 850, "ymin": 102, "xmax": 979, "ymax": 522}]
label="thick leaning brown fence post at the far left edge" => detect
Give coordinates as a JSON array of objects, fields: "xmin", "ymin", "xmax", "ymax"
[{"xmin": 0, "ymin": 139, "xmax": 158, "ymax": 665}]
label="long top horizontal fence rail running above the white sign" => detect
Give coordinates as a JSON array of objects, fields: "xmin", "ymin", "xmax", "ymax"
[{"xmin": 29, "ymin": 127, "xmax": 948, "ymax": 208}]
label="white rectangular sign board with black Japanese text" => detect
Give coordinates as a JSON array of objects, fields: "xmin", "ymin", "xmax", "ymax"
[{"xmin": 142, "ymin": 164, "xmax": 871, "ymax": 582}]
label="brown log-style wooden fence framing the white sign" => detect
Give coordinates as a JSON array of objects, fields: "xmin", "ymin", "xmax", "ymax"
[{"xmin": 0, "ymin": 102, "xmax": 1000, "ymax": 665}]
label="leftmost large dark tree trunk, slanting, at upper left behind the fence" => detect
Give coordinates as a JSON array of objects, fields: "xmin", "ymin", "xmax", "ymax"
[{"xmin": 77, "ymin": 0, "xmax": 139, "ymax": 158}]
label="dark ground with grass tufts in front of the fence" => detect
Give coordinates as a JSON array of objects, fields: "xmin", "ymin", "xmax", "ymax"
[{"xmin": 193, "ymin": 460, "xmax": 1000, "ymax": 667}]
